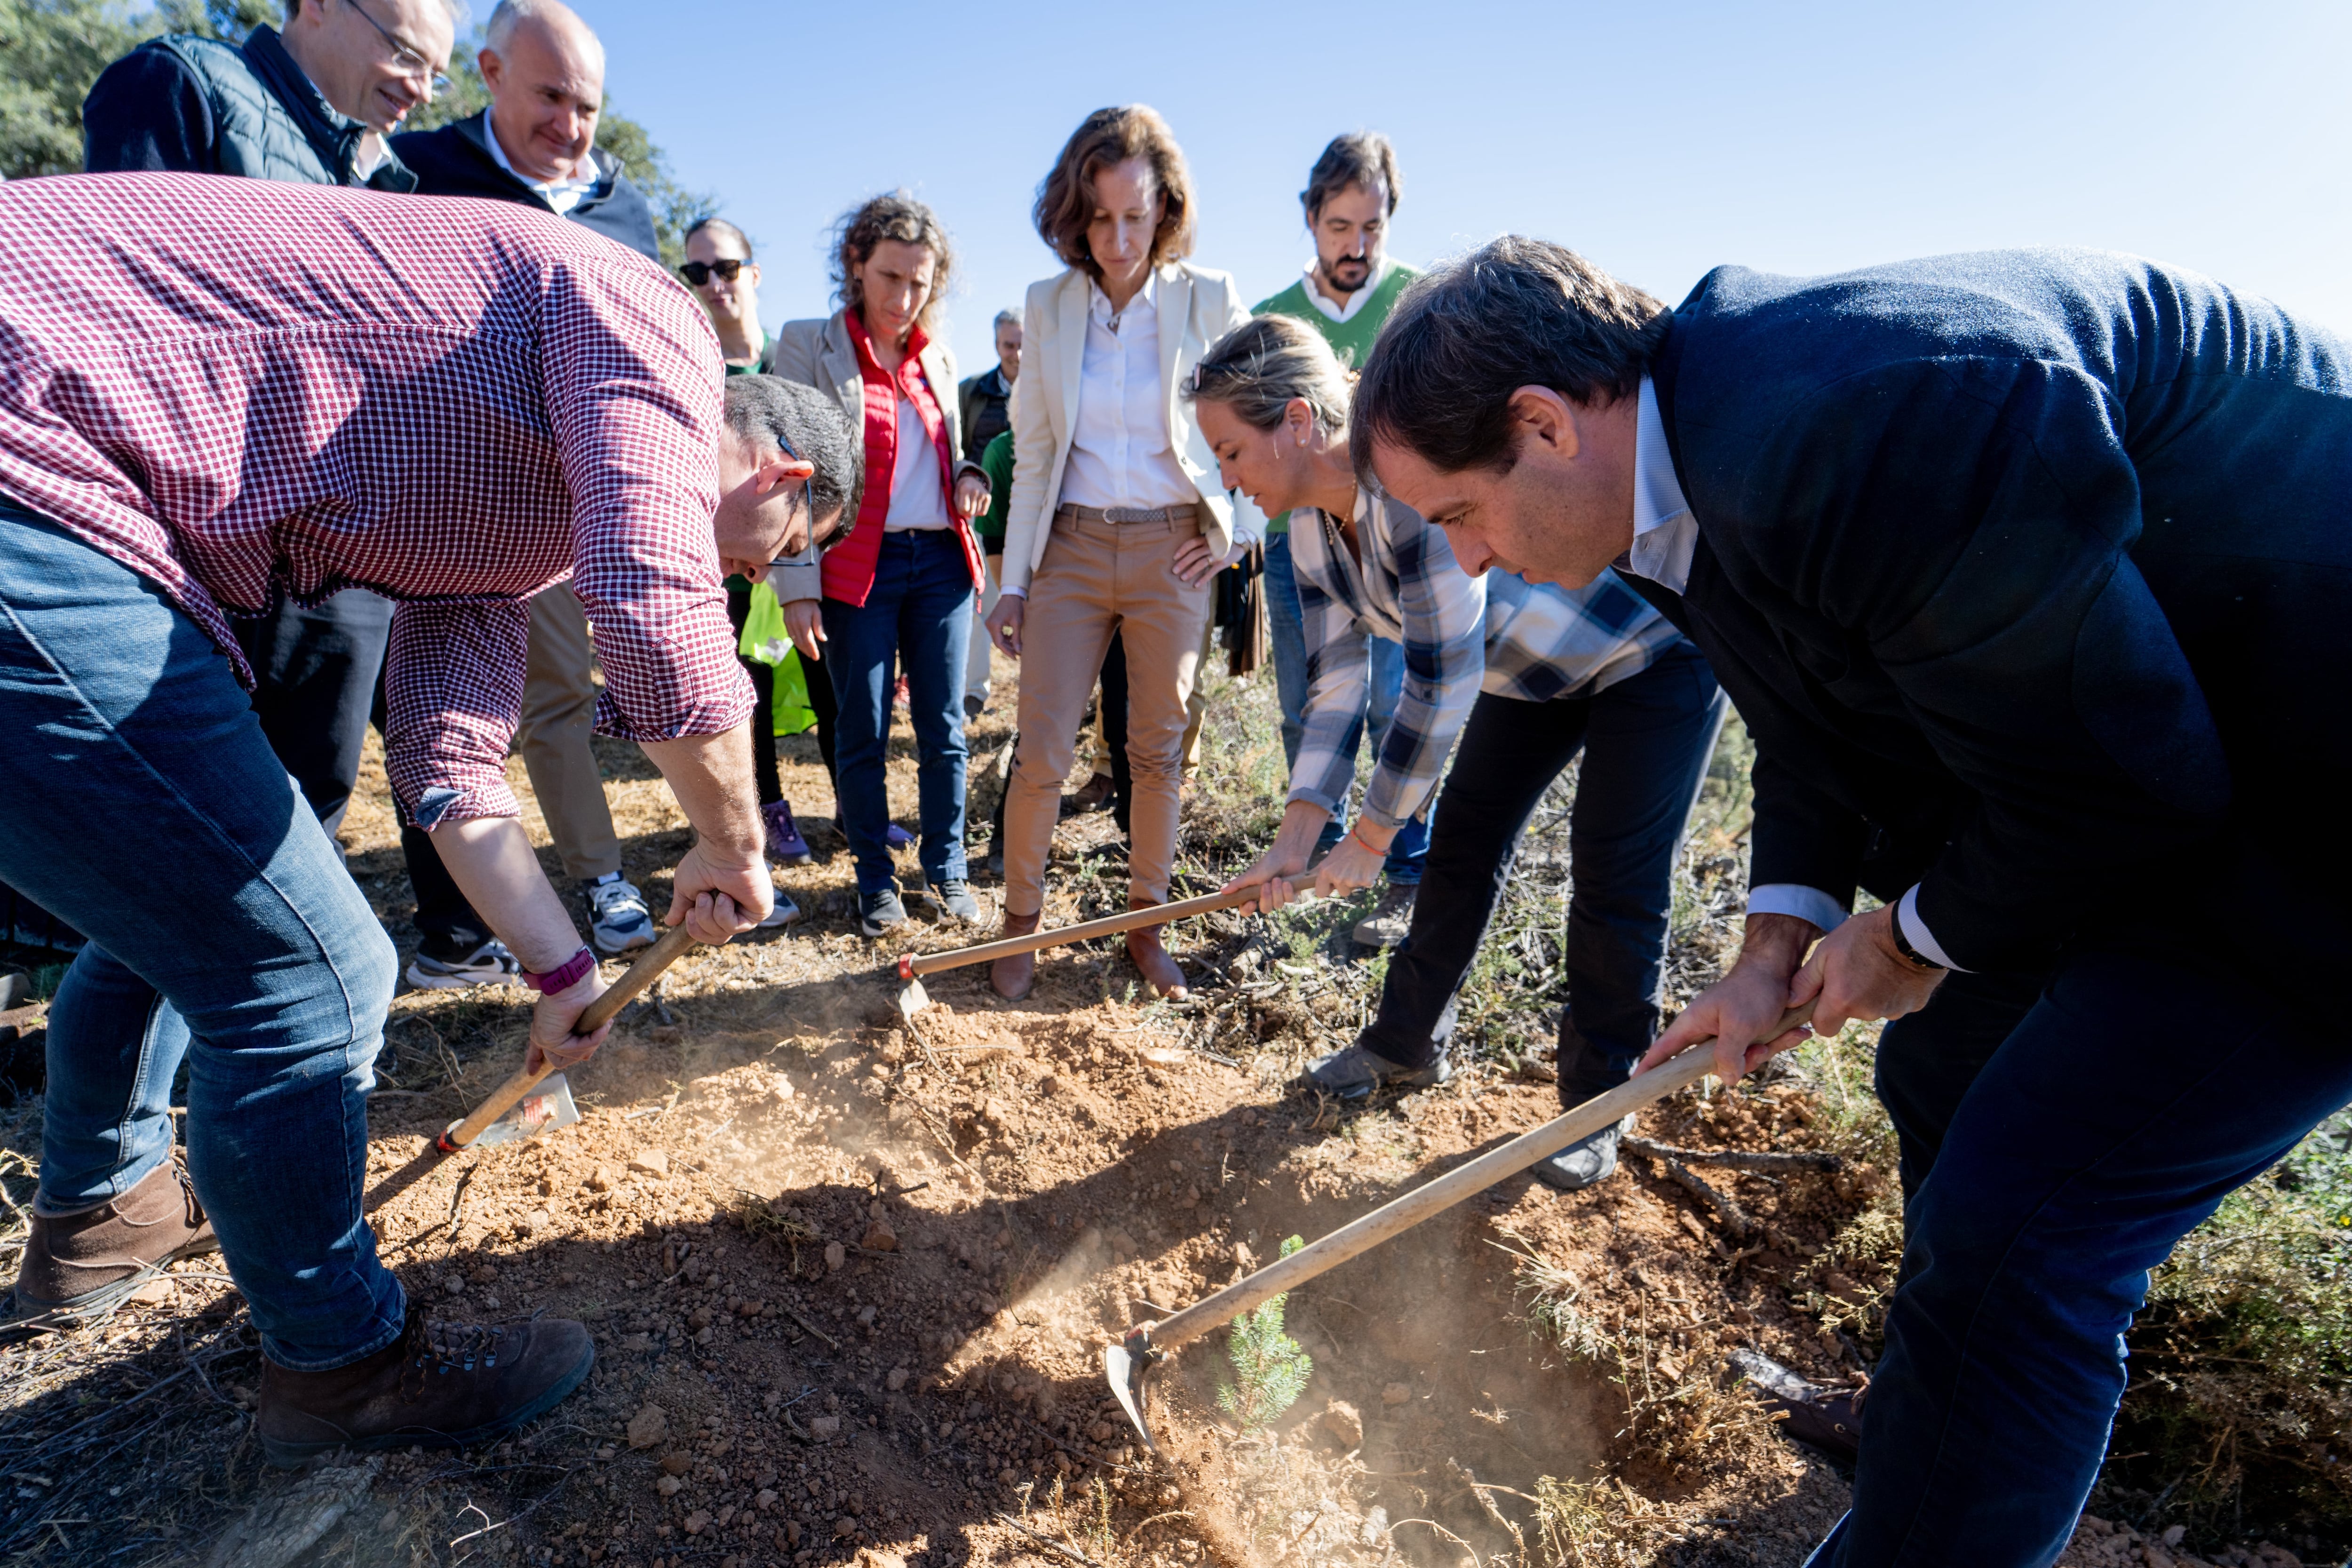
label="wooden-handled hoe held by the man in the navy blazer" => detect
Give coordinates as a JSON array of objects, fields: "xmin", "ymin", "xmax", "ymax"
[{"xmin": 1103, "ymin": 1002, "xmax": 1813, "ymax": 1453}]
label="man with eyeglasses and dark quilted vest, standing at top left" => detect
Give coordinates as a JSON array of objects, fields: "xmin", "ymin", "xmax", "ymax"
[{"xmin": 82, "ymin": 0, "xmax": 456, "ymax": 959}]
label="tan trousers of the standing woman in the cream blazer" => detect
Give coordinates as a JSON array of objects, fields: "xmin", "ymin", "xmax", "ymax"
[{"xmin": 1004, "ymin": 517, "xmax": 1209, "ymax": 915}]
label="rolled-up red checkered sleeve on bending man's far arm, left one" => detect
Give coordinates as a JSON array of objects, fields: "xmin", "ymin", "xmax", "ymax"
[{"xmin": 383, "ymin": 590, "xmax": 532, "ymax": 830}]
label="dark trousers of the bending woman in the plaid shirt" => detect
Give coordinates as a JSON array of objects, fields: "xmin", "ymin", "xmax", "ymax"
[{"xmin": 1362, "ymin": 642, "xmax": 1726, "ymax": 1105}]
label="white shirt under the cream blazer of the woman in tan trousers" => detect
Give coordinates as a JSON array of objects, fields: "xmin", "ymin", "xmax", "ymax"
[{"xmin": 1061, "ymin": 273, "xmax": 1200, "ymax": 508}]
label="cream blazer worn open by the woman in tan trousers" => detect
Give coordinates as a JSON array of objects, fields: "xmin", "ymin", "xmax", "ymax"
[{"xmin": 1004, "ymin": 261, "xmax": 1265, "ymax": 590}]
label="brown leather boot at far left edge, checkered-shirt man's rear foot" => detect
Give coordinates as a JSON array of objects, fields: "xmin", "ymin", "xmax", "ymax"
[{"xmin": 12, "ymin": 1152, "xmax": 221, "ymax": 1328}]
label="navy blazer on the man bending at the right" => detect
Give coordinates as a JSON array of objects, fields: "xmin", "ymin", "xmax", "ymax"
[{"xmin": 1628, "ymin": 252, "xmax": 2352, "ymax": 969}]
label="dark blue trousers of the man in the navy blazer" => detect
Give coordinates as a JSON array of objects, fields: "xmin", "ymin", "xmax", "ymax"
[{"xmin": 1813, "ymin": 952, "xmax": 2352, "ymax": 1568}]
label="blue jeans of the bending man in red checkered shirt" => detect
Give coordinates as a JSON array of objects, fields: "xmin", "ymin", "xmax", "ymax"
[{"xmin": 0, "ymin": 503, "xmax": 405, "ymax": 1370}]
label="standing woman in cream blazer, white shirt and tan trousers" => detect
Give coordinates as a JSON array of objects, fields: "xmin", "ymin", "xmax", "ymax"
[{"xmin": 988, "ymin": 106, "xmax": 1265, "ymax": 997}]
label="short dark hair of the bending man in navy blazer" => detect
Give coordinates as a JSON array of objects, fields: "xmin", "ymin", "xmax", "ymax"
[{"xmin": 1348, "ymin": 235, "xmax": 1675, "ymax": 472}]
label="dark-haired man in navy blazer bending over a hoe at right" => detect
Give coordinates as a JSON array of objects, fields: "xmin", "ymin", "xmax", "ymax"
[{"xmin": 1352, "ymin": 238, "xmax": 2352, "ymax": 1568}]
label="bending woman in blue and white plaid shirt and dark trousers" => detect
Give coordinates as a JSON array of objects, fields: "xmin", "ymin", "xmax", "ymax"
[{"xmin": 1188, "ymin": 315, "xmax": 1724, "ymax": 1192}]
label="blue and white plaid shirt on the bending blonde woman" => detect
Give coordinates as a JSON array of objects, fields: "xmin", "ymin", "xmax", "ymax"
[{"xmin": 1289, "ymin": 486, "xmax": 1679, "ymax": 828}]
